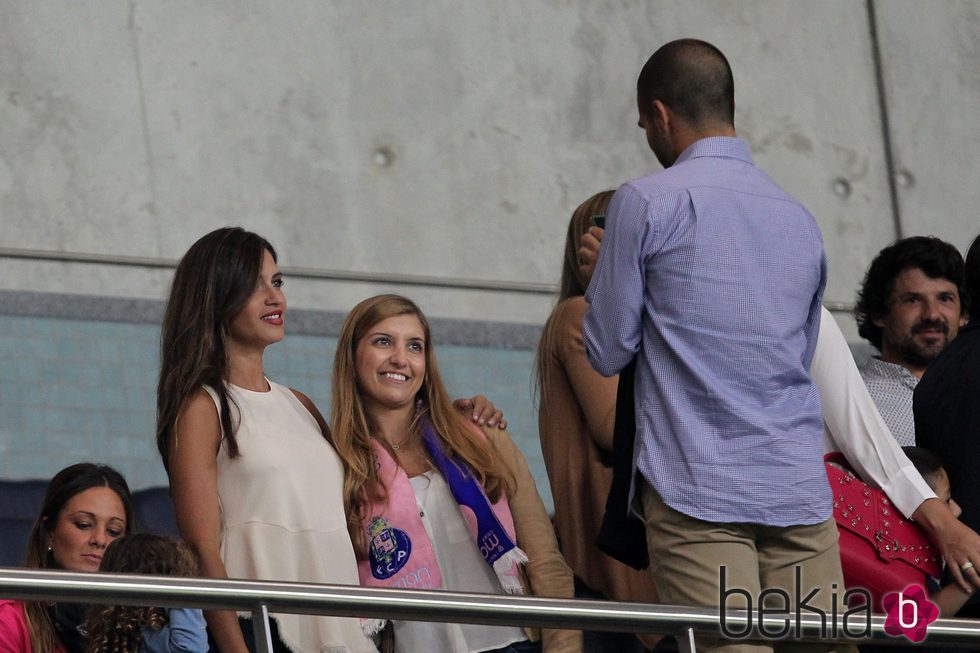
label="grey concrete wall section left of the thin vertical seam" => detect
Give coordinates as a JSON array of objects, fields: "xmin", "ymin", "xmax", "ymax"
[{"xmin": 0, "ymin": 1, "xmax": 159, "ymax": 258}]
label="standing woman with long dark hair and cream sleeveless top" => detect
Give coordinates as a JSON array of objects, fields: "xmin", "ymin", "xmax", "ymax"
[{"xmin": 157, "ymin": 228, "xmax": 374, "ymax": 653}]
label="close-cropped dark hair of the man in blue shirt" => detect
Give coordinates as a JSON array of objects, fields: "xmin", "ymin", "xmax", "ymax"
[{"xmin": 636, "ymin": 39, "xmax": 735, "ymax": 127}]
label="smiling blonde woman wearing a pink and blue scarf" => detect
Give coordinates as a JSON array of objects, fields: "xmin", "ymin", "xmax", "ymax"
[{"xmin": 331, "ymin": 295, "xmax": 581, "ymax": 653}]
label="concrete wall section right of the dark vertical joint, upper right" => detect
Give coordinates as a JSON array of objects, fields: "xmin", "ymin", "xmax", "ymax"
[{"xmin": 876, "ymin": 0, "xmax": 980, "ymax": 253}]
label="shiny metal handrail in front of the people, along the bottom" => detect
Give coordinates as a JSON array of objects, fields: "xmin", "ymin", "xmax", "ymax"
[{"xmin": 0, "ymin": 568, "xmax": 980, "ymax": 647}]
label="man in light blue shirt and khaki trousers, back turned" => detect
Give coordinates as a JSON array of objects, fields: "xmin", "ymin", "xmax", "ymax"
[{"xmin": 584, "ymin": 39, "xmax": 844, "ymax": 650}]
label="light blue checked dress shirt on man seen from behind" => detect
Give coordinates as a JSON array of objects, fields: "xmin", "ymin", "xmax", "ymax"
[{"xmin": 584, "ymin": 137, "xmax": 831, "ymax": 526}]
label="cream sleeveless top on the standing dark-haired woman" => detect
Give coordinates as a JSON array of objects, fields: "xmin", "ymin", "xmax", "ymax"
[{"xmin": 205, "ymin": 381, "xmax": 377, "ymax": 653}]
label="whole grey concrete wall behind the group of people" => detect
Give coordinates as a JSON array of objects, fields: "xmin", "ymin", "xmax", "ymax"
[{"xmin": 0, "ymin": 0, "xmax": 980, "ymax": 492}]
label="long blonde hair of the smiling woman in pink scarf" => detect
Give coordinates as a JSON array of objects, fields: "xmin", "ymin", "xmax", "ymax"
[{"xmin": 331, "ymin": 295, "xmax": 513, "ymax": 557}]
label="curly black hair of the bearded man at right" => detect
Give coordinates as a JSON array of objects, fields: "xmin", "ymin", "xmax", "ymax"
[{"xmin": 854, "ymin": 236, "xmax": 970, "ymax": 351}]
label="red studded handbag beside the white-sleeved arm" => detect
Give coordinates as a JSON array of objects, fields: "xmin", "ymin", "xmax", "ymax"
[{"xmin": 824, "ymin": 452, "xmax": 943, "ymax": 612}]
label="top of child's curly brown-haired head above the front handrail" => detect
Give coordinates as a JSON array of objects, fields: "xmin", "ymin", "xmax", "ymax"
[{"xmin": 99, "ymin": 533, "xmax": 197, "ymax": 576}]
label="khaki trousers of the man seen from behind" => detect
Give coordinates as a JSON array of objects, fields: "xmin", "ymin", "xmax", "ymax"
[{"xmin": 640, "ymin": 483, "xmax": 856, "ymax": 653}]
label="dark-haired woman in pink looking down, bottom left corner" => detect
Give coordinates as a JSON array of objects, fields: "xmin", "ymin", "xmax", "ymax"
[{"xmin": 0, "ymin": 463, "xmax": 135, "ymax": 653}]
